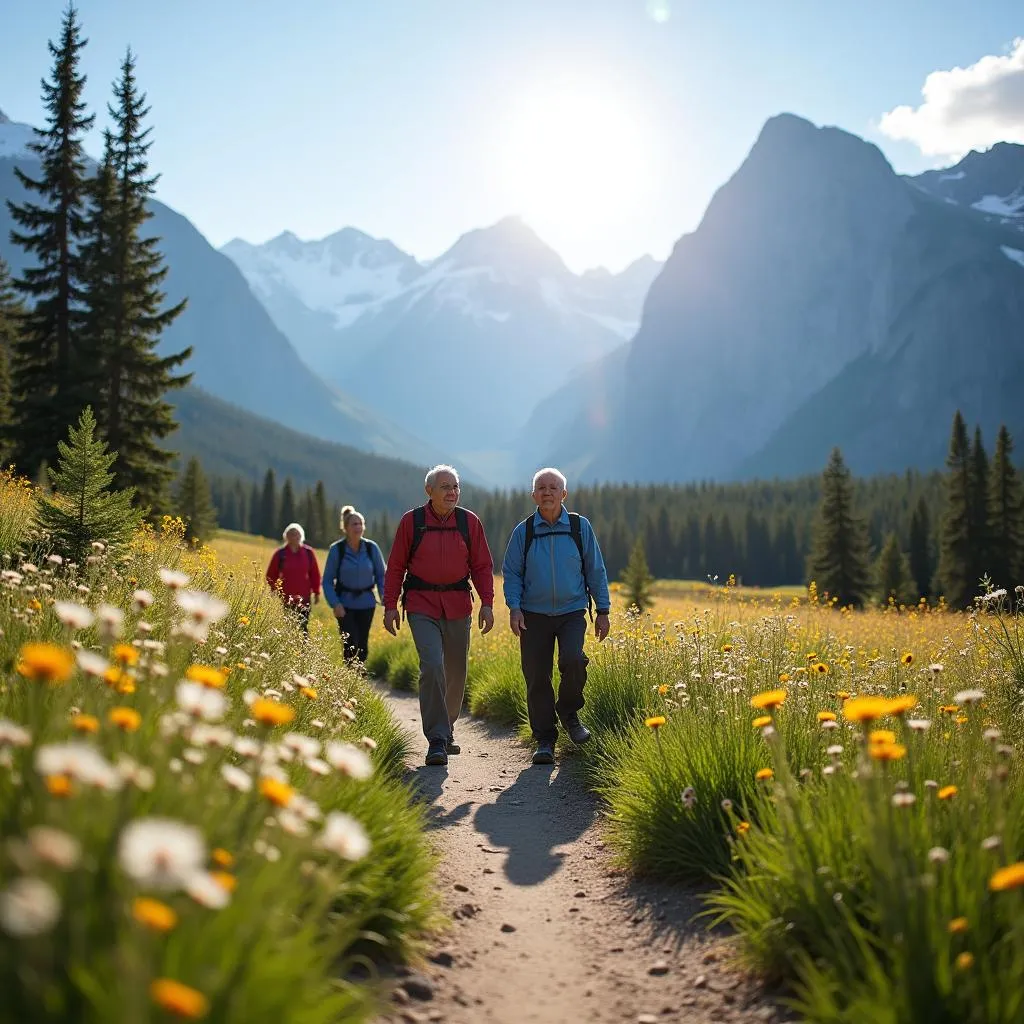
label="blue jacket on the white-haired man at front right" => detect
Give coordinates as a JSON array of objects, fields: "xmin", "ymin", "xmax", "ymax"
[{"xmin": 502, "ymin": 506, "xmax": 611, "ymax": 615}]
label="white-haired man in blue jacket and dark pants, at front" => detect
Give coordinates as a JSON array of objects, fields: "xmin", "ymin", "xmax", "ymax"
[{"xmin": 502, "ymin": 468, "xmax": 611, "ymax": 765}]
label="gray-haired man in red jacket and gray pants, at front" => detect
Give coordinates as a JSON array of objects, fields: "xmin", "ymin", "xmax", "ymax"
[{"xmin": 384, "ymin": 466, "xmax": 495, "ymax": 765}]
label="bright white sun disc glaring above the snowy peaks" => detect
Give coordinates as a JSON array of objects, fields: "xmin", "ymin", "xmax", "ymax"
[{"xmin": 501, "ymin": 82, "xmax": 650, "ymax": 256}]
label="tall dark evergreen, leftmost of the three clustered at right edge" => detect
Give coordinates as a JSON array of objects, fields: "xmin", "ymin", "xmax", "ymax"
[{"xmin": 935, "ymin": 410, "xmax": 979, "ymax": 608}]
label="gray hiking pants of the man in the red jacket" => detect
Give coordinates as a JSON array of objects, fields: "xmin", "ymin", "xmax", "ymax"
[{"xmin": 409, "ymin": 612, "xmax": 472, "ymax": 740}]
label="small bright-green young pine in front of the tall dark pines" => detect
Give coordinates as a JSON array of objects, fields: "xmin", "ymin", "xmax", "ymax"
[{"xmin": 37, "ymin": 406, "xmax": 142, "ymax": 562}]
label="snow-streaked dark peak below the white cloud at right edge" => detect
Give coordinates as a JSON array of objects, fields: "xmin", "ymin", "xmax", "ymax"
[{"xmin": 910, "ymin": 142, "xmax": 1024, "ymax": 231}]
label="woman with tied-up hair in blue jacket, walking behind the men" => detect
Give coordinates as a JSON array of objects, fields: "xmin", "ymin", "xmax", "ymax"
[{"xmin": 324, "ymin": 505, "xmax": 384, "ymax": 664}]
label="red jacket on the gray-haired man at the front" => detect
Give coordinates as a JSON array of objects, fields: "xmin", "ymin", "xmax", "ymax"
[{"xmin": 384, "ymin": 502, "xmax": 495, "ymax": 618}]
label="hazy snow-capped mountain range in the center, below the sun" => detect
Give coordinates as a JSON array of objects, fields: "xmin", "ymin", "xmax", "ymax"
[{"xmin": 222, "ymin": 217, "xmax": 660, "ymax": 465}]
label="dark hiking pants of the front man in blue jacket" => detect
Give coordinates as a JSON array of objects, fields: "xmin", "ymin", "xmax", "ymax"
[{"xmin": 519, "ymin": 611, "xmax": 590, "ymax": 743}]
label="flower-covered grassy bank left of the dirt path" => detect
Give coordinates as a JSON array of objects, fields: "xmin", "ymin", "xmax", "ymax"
[{"xmin": 0, "ymin": 493, "xmax": 436, "ymax": 1024}]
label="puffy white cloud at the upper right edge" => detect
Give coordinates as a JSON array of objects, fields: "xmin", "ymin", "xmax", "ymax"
[{"xmin": 879, "ymin": 38, "xmax": 1024, "ymax": 160}]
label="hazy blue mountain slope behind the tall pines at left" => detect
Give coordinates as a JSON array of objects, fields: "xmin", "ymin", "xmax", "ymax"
[{"xmin": 0, "ymin": 107, "xmax": 437, "ymax": 461}]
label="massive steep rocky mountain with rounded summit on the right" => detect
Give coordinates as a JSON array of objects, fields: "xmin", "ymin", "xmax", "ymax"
[{"xmin": 528, "ymin": 115, "xmax": 1024, "ymax": 480}]
